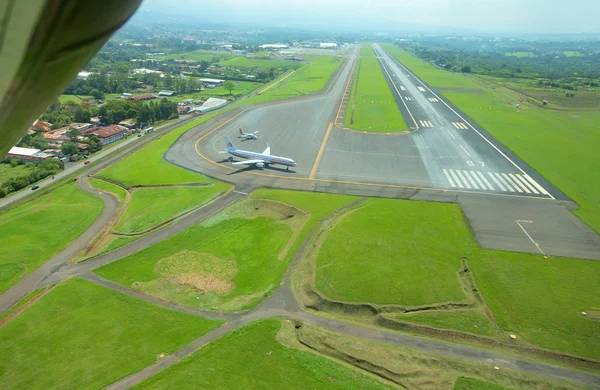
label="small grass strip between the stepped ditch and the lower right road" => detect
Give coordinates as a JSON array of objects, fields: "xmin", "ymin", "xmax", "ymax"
[{"xmin": 396, "ymin": 311, "xmax": 497, "ymax": 336}]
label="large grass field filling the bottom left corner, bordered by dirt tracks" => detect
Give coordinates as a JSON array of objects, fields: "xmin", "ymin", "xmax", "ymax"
[{"xmin": 0, "ymin": 279, "xmax": 219, "ymax": 389}]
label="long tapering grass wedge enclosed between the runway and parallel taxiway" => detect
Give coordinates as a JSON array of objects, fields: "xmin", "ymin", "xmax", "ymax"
[{"xmin": 346, "ymin": 46, "xmax": 407, "ymax": 133}]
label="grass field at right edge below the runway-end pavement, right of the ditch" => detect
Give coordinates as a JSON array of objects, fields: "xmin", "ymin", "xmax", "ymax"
[{"xmin": 470, "ymin": 250, "xmax": 600, "ymax": 359}]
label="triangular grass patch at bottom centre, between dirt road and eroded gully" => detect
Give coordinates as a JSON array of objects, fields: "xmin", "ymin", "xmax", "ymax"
[{"xmin": 135, "ymin": 319, "xmax": 388, "ymax": 389}]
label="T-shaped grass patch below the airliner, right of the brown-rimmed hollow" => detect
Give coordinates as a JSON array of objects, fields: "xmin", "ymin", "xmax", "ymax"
[{"xmin": 250, "ymin": 188, "xmax": 360, "ymax": 261}]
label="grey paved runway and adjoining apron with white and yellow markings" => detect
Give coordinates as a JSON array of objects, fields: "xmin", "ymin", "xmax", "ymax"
[{"xmin": 165, "ymin": 45, "xmax": 600, "ymax": 260}]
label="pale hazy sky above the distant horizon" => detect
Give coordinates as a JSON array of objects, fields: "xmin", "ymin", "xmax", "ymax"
[{"xmin": 140, "ymin": 0, "xmax": 600, "ymax": 33}]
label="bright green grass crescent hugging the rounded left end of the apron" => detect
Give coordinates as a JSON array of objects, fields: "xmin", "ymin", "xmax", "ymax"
[{"xmin": 98, "ymin": 116, "xmax": 213, "ymax": 187}]
